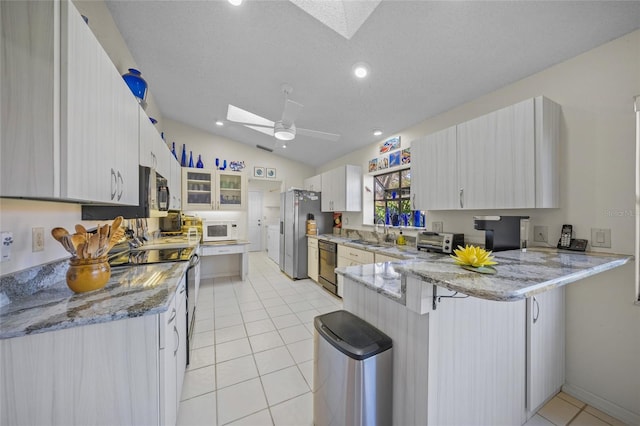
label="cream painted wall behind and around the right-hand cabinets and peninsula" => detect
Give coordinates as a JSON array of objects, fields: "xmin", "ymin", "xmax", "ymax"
[{"xmin": 319, "ymin": 31, "xmax": 640, "ymax": 424}]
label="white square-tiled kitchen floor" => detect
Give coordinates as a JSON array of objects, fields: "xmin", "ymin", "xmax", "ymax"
[{"xmin": 178, "ymin": 252, "xmax": 623, "ymax": 426}]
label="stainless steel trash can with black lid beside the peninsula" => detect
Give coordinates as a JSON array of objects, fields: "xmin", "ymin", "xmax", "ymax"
[{"xmin": 313, "ymin": 311, "xmax": 393, "ymax": 426}]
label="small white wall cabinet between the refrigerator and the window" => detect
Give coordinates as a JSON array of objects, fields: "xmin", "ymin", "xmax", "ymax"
[{"xmin": 320, "ymin": 164, "xmax": 362, "ymax": 212}]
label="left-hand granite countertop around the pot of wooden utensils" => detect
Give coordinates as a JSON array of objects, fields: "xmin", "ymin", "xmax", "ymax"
[{"xmin": 0, "ymin": 262, "xmax": 189, "ymax": 339}]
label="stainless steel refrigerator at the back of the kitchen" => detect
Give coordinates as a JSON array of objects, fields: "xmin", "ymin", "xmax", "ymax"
[{"xmin": 280, "ymin": 189, "xmax": 333, "ymax": 279}]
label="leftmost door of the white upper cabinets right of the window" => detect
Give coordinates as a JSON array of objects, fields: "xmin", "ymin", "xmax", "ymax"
[{"xmin": 411, "ymin": 126, "xmax": 459, "ymax": 210}]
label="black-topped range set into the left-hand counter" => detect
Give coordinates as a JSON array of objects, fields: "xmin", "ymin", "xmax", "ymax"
[{"xmin": 109, "ymin": 246, "xmax": 200, "ymax": 365}]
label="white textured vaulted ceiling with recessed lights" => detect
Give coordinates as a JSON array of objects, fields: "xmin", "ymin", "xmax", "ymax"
[{"xmin": 106, "ymin": 0, "xmax": 640, "ymax": 166}]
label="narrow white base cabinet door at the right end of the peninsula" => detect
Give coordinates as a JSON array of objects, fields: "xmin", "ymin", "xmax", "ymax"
[{"xmin": 527, "ymin": 287, "xmax": 565, "ymax": 416}]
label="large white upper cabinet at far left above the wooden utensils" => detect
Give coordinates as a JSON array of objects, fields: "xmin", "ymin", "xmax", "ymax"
[{"xmin": 0, "ymin": 1, "xmax": 138, "ymax": 205}]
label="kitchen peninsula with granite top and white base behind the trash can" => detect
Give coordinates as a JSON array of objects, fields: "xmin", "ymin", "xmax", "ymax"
[{"xmin": 337, "ymin": 249, "xmax": 632, "ymax": 425}]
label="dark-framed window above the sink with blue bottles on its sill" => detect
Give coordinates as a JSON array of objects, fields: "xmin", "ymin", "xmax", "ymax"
[{"xmin": 373, "ymin": 169, "xmax": 424, "ymax": 226}]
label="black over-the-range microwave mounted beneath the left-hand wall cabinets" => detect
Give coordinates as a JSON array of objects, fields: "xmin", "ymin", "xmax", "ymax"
[{"xmin": 82, "ymin": 166, "xmax": 169, "ymax": 220}]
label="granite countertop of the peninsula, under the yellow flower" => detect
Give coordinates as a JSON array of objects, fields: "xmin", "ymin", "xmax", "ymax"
[{"xmin": 336, "ymin": 248, "xmax": 633, "ymax": 304}]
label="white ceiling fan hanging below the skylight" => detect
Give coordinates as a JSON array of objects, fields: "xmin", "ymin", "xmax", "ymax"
[{"xmin": 227, "ymin": 84, "xmax": 340, "ymax": 148}]
